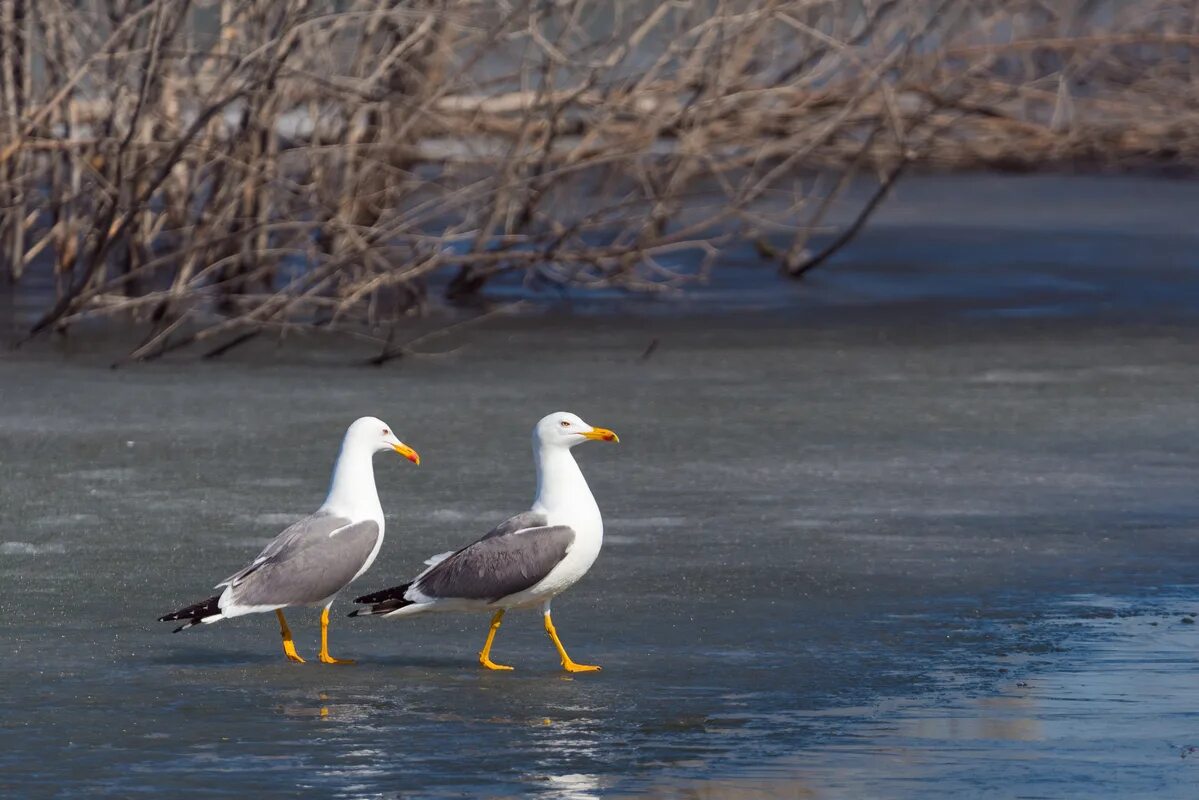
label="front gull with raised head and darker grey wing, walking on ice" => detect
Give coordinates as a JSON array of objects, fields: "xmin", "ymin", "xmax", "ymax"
[{"xmin": 350, "ymin": 411, "xmax": 620, "ymax": 672}]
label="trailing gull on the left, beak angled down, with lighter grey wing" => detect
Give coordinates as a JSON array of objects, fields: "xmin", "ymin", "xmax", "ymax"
[{"xmin": 158, "ymin": 416, "xmax": 421, "ymax": 664}]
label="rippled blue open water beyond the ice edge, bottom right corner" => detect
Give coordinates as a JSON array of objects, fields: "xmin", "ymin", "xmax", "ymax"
[{"xmin": 651, "ymin": 589, "xmax": 1199, "ymax": 798}]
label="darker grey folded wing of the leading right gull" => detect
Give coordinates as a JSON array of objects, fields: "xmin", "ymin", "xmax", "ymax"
[{"xmin": 414, "ymin": 525, "xmax": 574, "ymax": 601}]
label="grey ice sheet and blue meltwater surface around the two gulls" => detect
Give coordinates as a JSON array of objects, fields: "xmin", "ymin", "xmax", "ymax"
[{"xmin": 0, "ymin": 173, "xmax": 1199, "ymax": 798}]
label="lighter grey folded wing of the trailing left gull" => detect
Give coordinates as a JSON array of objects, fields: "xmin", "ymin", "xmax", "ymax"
[{"xmin": 223, "ymin": 521, "xmax": 379, "ymax": 606}]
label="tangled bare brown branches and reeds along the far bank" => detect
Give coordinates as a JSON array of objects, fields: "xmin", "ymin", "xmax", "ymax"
[{"xmin": 0, "ymin": 0, "xmax": 1199, "ymax": 360}]
